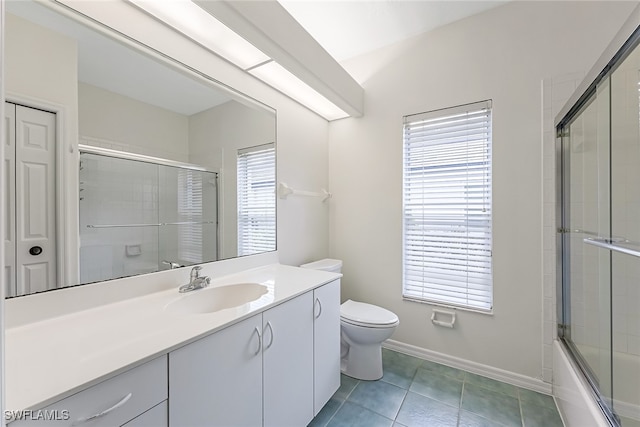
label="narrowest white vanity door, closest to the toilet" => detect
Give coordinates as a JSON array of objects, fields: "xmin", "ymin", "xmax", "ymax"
[{"xmin": 313, "ymin": 279, "xmax": 340, "ymax": 416}]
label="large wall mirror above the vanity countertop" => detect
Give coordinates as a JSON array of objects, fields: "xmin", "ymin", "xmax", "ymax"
[{"xmin": 4, "ymin": 0, "xmax": 276, "ymax": 297}]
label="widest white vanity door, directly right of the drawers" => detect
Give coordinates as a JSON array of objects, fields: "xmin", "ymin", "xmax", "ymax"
[{"xmin": 169, "ymin": 315, "xmax": 262, "ymax": 427}]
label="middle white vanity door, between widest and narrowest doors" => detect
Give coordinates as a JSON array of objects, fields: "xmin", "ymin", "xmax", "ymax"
[{"xmin": 263, "ymin": 292, "xmax": 313, "ymax": 427}]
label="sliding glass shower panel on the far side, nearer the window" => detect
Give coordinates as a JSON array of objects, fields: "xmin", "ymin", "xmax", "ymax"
[{"xmin": 560, "ymin": 79, "xmax": 613, "ymax": 414}]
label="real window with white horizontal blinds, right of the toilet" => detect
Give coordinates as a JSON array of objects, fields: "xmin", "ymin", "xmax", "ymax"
[{"xmin": 403, "ymin": 101, "xmax": 493, "ymax": 311}]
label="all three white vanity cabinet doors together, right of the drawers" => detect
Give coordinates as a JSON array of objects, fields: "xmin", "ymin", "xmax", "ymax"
[{"xmin": 169, "ymin": 280, "xmax": 340, "ymax": 427}]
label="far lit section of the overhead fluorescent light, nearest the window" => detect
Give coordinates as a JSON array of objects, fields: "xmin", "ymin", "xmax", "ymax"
[{"xmin": 249, "ymin": 61, "xmax": 349, "ymax": 120}]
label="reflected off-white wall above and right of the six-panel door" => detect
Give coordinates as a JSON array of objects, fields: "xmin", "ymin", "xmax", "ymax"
[{"xmin": 2, "ymin": 10, "xmax": 78, "ymax": 283}]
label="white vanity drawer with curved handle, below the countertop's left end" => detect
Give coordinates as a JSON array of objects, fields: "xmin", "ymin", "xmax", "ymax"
[{"xmin": 10, "ymin": 356, "xmax": 168, "ymax": 427}]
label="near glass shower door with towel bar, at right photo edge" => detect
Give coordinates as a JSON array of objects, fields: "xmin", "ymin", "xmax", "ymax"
[{"xmin": 611, "ymin": 39, "xmax": 640, "ymax": 427}]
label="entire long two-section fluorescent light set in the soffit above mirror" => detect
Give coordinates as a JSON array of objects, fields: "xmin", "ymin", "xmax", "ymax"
[{"xmin": 128, "ymin": 0, "xmax": 349, "ymax": 120}]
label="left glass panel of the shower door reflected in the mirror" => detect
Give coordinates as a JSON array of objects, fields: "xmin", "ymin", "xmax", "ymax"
[{"xmin": 79, "ymin": 153, "xmax": 159, "ymax": 283}]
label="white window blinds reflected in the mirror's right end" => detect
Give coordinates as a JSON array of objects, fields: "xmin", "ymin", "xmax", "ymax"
[{"xmin": 238, "ymin": 144, "xmax": 276, "ymax": 256}]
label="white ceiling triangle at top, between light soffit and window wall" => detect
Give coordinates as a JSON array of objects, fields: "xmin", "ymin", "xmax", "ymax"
[{"xmin": 278, "ymin": 0, "xmax": 507, "ymax": 62}]
